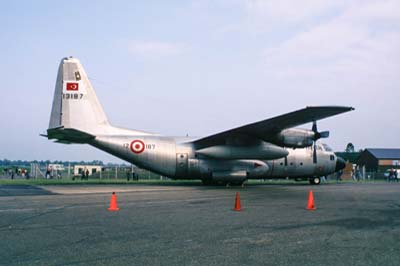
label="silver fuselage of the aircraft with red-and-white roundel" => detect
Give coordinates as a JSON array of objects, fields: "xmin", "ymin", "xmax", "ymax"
[{"xmin": 89, "ymin": 135, "xmax": 337, "ymax": 181}]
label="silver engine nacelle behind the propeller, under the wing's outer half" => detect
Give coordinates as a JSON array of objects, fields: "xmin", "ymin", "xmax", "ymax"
[{"xmin": 276, "ymin": 128, "xmax": 315, "ymax": 148}]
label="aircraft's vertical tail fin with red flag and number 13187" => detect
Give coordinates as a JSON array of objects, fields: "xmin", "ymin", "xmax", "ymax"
[{"xmin": 47, "ymin": 57, "xmax": 111, "ymax": 142}]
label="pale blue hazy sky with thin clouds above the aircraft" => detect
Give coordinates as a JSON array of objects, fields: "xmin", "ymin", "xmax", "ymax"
[{"xmin": 0, "ymin": 0, "xmax": 400, "ymax": 162}]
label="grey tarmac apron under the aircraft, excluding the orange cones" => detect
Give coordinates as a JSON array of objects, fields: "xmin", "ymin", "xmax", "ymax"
[{"xmin": 0, "ymin": 183, "xmax": 400, "ymax": 266}]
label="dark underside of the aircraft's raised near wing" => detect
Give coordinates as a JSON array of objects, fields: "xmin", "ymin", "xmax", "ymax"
[{"xmin": 192, "ymin": 106, "xmax": 354, "ymax": 148}]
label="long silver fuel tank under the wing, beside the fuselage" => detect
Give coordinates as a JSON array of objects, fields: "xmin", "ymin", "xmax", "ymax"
[{"xmin": 196, "ymin": 142, "xmax": 289, "ymax": 160}]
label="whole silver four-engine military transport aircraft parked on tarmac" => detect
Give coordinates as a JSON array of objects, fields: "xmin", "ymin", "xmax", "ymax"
[{"xmin": 44, "ymin": 57, "xmax": 354, "ymax": 184}]
